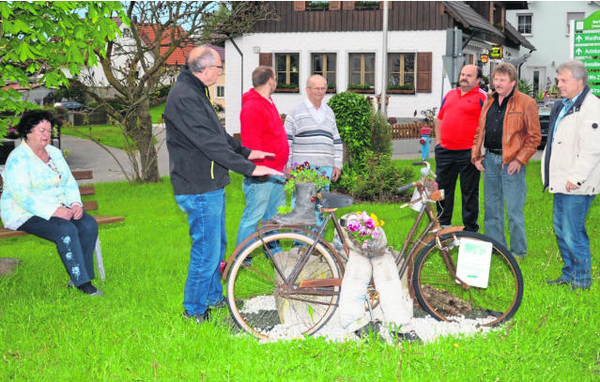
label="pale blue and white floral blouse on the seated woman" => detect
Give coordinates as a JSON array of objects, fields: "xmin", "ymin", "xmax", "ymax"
[{"xmin": 0, "ymin": 140, "xmax": 82, "ymax": 230}]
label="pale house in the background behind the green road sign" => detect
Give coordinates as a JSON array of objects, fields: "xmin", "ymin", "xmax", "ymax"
[{"xmin": 506, "ymin": 1, "xmax": 600, "ymax": 93}]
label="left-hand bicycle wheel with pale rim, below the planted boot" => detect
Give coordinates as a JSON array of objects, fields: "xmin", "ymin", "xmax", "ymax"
[{"xmin": 227, "ymin": 232, "xmax": 341, "ymax": 339}]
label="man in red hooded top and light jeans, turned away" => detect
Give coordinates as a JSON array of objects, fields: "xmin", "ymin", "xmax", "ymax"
[{"xmin": 236, "ymin": 66, "xmax": 290, "ymax": 256}]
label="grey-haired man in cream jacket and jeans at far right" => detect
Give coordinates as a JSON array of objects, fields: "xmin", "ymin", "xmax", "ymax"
[{"xmin": 542, "ymin": 61, "xmax": 600, "ymax": 290}]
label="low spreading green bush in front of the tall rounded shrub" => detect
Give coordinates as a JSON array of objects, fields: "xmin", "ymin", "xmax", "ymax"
[{"xmin": 332, "ymin": 150, "xmax": 414, "ymax": 202}]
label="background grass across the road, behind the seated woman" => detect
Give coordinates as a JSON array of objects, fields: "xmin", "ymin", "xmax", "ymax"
[{"xmin": 61, "ymin": 103, "xmax": 165, "ymax": 150}]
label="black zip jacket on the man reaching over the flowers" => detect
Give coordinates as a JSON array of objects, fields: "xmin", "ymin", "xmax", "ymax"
[{"xmin": 164, "ymin": 67, "xmax": 256, "ymax": 195}]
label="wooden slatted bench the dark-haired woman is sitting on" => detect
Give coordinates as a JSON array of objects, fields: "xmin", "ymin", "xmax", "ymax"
[{"xmin": 0, "ymin": 170, "xmax": 125, "ymax": 280}]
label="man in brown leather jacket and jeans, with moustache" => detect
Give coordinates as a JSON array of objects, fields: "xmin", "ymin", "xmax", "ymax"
[{"xmin": 471, "ymin": 63, "xmax": 541, "ymax": 259}]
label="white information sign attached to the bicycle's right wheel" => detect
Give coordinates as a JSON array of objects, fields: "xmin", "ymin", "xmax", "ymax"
[{"xmin": 456, "ymin": 239, "xmax": 492, "ymax": 288}]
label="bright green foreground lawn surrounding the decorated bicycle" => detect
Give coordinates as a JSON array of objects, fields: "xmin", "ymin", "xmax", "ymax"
[{"xmin": 0, "ymin": 161, "xmax": 600, "ymax": 381}]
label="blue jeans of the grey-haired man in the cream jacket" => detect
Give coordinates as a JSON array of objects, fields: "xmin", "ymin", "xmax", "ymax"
[{"xmin": 554, "ymin": 194, "xmax": 596, "ymax": 288}]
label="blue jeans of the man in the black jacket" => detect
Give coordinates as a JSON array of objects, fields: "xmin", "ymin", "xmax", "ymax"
[{"xmin": 175, "ymin": 189, "xmax": 227, "ymax": 316}]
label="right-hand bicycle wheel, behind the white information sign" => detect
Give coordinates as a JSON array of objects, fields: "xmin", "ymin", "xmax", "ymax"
[{"xmin": 413, "ymin": 231, "xmax": 523, "ymax": 326}]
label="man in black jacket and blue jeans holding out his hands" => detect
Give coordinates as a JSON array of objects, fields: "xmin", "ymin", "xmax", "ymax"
[{"xmin": 164, "ymin": 47, "xmax": 283, "ymax": 323}]
